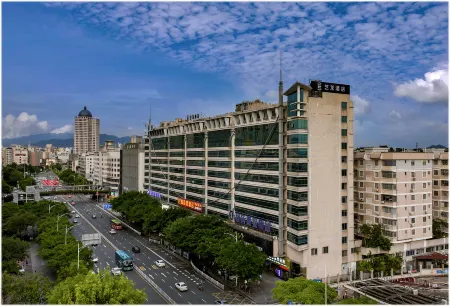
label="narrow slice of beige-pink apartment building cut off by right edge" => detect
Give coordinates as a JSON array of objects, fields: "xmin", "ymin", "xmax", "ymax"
[{"xmin": 433, "ymin": 150, "xmax": 448, "ymax": 225}]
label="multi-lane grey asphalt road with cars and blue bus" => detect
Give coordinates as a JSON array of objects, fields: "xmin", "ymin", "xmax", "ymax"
[{"xmin": 58, "ymin": 195, "xmax": 223, "ymax": 304}]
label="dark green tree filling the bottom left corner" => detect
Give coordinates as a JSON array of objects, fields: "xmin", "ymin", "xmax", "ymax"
[{"xmin": 2, "ymin": 273, "xmax": 53, "ymax": 305}]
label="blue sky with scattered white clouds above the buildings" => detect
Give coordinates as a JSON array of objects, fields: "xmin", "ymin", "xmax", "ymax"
[{"xmin": 2, "ymin": 2, "xmax": 448, "ymax": 147}]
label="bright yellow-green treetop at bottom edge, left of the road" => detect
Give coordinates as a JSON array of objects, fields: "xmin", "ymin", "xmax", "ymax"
[{"xmin": 48, "ymin": 271, "xmax": 146, "ymax": 304}]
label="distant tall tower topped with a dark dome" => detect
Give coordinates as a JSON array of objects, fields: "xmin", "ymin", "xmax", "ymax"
[{"xmin": 73, "ymin": 106, "xmax": 100, "ymax": 155}]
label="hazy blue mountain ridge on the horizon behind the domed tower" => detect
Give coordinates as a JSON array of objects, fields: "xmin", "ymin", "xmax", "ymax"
[{"xmin": 2, "ymin": 133, "xmax": 134, "ymax": 147}]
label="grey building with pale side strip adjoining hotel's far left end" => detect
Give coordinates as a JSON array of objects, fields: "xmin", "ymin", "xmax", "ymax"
[{"xmin": 120, "ymin": 143, "xmax": 145, "ymax": 191}]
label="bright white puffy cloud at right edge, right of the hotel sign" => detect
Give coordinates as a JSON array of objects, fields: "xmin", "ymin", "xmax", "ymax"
[{"xmin": 395, "ymin": 64, "xmax": 448, "ymax": 103}]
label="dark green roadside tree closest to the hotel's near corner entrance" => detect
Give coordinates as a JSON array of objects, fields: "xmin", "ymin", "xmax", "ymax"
[{"xmin": 216, "ymin": 238, "xmax": 267, "ymax": 280}]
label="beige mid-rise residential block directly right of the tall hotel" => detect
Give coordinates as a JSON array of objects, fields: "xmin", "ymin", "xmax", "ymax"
[{"xmin": 354, "ymin": 147, "xmax": 434, "ymax": 245}]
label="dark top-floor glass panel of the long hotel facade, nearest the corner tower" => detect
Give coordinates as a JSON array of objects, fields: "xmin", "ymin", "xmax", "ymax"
[{"xmin": 235, "ymin": 123, "xmax": 278, "ymax": 146}]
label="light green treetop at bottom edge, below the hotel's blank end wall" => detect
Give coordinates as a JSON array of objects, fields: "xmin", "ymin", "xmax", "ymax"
[{"xmin": 272, "ymin": 277, "xmax": 337, "ymax": 305}]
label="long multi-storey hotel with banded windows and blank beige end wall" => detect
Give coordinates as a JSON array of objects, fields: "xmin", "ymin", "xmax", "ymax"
[{"xmin": 145, "ymin": 81, "xmax": 359, "ymax": 278}]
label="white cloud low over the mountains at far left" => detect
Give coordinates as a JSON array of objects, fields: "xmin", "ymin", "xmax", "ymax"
[{"xmin": 2, "ymin": 112, "xmax": 49, "ymax": 138}]
